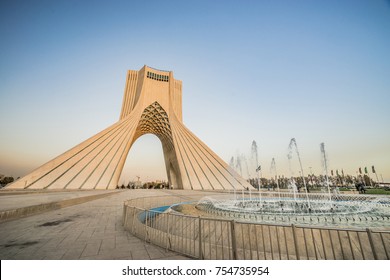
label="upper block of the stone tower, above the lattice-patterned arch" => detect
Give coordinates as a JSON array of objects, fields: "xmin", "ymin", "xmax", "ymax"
[{"xmin": 120, "ymin": 65, "xmax": 182, "ymax": 121}]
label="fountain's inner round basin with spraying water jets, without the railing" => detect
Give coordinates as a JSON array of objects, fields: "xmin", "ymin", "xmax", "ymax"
[{"xmin": 191, "ymin": 138, "xmax": 390, "ymax": 227}]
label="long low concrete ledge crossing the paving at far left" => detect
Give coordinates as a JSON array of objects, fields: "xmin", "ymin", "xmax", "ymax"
[{"xmin": 0, "ymin": 191, "xmax": 118, "ymax": 223}]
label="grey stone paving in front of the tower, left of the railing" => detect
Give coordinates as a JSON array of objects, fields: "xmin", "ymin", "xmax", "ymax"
[{"xmin": 0, "ymin": 190, "xmax": 192, "ymax": 260}]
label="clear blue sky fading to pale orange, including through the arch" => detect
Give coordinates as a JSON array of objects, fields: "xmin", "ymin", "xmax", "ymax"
[{"xmin": 0, "ymin": 0, "xmax": 390, "ymax": 181}]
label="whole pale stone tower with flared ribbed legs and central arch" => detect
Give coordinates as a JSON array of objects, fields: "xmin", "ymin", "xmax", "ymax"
[{"xmin": 7, "ymin": 66, "xmax": 251, "ymax": 190}]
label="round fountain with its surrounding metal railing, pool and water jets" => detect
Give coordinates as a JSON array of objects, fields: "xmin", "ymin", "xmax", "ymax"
[{"xmin": 124, "ymin": 138, "xmax": 390, "ymax": 260}]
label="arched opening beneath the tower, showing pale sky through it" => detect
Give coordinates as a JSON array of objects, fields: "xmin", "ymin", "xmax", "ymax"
[{"xmin": 118, "ymin": 133, "xmax": 168, "ymax": 187}]
